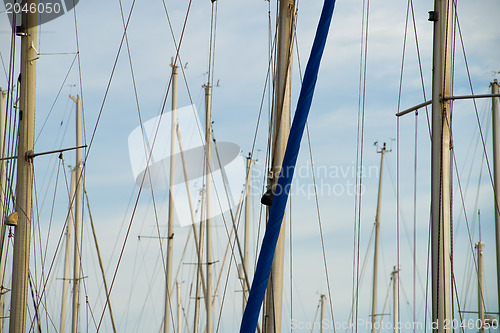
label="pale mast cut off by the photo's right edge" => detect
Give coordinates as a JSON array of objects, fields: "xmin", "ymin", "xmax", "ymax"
[{"xmin": 491, "ymin": 79, "xmax": 500, "ymax": 310}]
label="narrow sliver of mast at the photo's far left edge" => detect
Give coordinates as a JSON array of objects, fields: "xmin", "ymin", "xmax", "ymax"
[{"xmin": 0, "ymin": 89, "xmax": 8, "ymax": 333}]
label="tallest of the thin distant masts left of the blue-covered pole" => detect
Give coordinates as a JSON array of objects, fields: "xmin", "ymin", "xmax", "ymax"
[{"xmin": 163, "ymin": 58, "xmax": 178, "ymax": 333}]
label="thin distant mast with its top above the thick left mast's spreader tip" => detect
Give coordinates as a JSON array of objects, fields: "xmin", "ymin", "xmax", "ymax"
[{"xmin": 70, "ymin": 96, "xmax": 83, "ymax": 333}]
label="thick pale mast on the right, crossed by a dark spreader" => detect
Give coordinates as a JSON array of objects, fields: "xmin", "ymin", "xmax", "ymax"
[{"xmin": 429, "ymin": 0, "xmax": 453, "ymax": 333}]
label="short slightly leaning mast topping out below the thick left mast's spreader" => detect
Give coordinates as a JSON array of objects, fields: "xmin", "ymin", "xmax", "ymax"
[{"xmin": 59, "ymin": 168, "xmax": 76, "ymax": 333}]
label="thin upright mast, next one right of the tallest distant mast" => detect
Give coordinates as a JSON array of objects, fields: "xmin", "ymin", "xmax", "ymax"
[{"xmin": 204, "ymin": 83, "xmax": 213, "ymax": 333}]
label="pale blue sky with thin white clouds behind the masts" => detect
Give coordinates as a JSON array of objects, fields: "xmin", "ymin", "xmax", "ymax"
[{"xmin": 0, "ymin": 0, "xmax": 500, "ymax": 332}]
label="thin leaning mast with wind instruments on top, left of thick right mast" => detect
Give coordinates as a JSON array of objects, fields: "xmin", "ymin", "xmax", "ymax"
[{"xmin": 371, "ymin": 142, "xmax": 388, "ymax": 333}]
